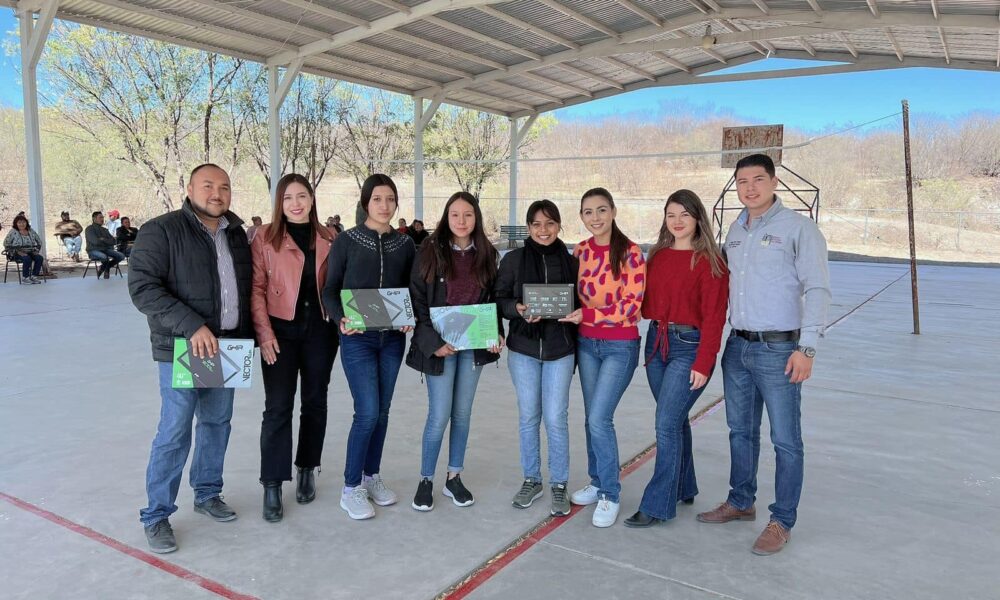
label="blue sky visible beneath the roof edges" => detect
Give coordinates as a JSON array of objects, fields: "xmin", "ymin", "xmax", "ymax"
[{"xmin": 0, "ymin": 10, "xmax": 1000, "ymax": 131}]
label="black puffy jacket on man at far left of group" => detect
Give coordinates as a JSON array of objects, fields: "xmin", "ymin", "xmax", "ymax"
[{"xmin": 128, "ymin": 199, "xmax": 254, "ymax": 362}]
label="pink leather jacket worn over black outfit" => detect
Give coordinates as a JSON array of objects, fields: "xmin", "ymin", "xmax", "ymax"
[{"xmin": 250, "ymin": 224, "xmax": 337, "ymax": 343}]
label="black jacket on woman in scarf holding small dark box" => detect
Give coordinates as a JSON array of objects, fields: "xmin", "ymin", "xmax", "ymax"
[{"xmin": 495, "ymin": 248, "xmax": 579, "ymax": 360}]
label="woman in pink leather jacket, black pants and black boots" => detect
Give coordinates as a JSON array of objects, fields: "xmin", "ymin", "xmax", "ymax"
[{"xmin": 250, "ymin": 173, "xmax": 340, "ymax": 522}]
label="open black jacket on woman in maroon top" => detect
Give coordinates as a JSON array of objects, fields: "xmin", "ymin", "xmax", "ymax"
[{"xmin": 406, "ymin": 250, "xmax": 504, "ymax": 375}]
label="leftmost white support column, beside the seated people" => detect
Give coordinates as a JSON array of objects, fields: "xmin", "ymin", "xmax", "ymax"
[{"xmin": 17, "ymin": 0, "xmax": 59, "ymax": 256}]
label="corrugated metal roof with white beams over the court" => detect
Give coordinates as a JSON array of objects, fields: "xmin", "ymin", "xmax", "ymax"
[{"xmin": 0, "ymin": 0, "xmax": 1000, "ymax": 118}]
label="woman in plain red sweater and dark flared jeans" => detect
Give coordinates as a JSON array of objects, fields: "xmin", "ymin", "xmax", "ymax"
[{"xmin": 625, "ymin": 190, "xmax": 729, "ymax": 527}]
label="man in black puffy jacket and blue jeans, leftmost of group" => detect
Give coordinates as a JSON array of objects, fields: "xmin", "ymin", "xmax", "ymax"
[{"xmin": 129, "ymin": 164, "xmax": 253, "ymax": 553}]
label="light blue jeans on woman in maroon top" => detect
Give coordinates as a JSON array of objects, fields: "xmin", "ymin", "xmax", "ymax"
[{"xmin": 420, "ymin": 350, "xmax": 483, "ymax": 479}]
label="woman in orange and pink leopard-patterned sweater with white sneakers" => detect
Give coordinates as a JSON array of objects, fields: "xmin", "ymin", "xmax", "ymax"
[{"xmin": 561, "ymin": 188, "xmax": 646, "ymax": 527}]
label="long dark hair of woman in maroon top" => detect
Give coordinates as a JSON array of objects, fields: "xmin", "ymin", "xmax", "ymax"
[{"xmin": 419, "ymin": 192, "xmax": 499, "ymax": 289}]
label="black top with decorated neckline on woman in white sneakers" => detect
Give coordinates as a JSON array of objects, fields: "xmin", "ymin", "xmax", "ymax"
[{"xmin": 323, "ymin": 224, "xmax": 415, "ymax": 327}]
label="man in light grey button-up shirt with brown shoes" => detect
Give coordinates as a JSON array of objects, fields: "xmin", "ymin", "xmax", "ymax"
[{"xmin": 698, "ymin": 154, "xmax": 830, "ymax": 555}]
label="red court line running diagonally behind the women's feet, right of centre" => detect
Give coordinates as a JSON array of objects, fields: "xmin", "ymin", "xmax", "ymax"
[{"xmin": 437, "ymin": 397, "xmax": 724, "ymax": 600}]
